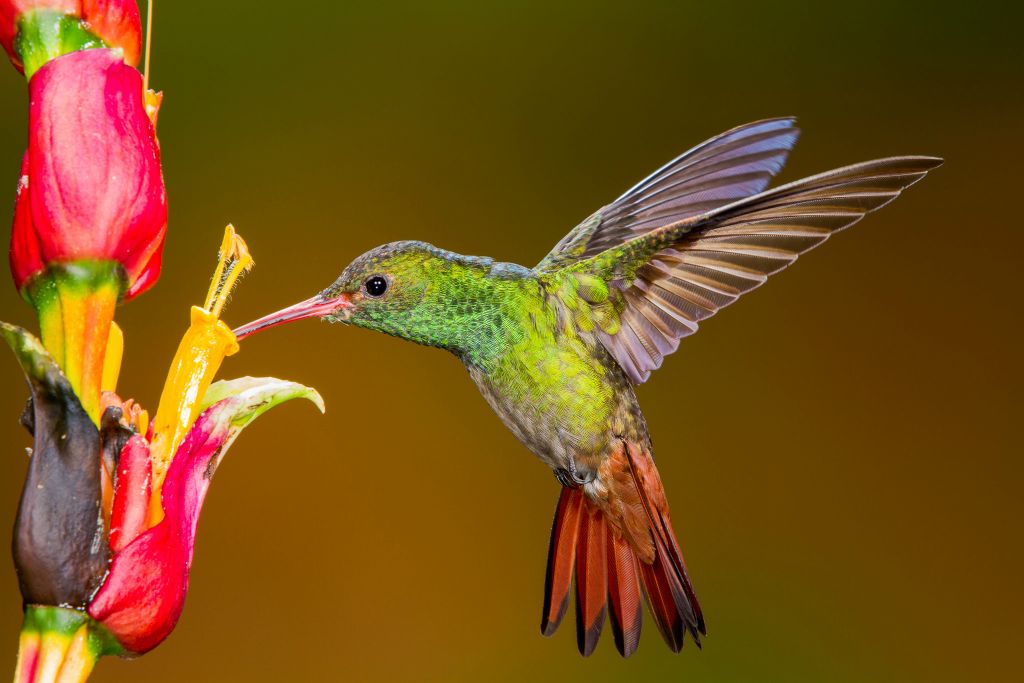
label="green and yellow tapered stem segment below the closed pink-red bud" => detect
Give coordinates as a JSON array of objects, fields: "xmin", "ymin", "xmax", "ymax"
[{"xmin": 22, "ymin": 261, "xmax": 124, "ymax": 424}]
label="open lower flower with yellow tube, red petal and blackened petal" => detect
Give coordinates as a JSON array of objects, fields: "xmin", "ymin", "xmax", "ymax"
[{"xmin": 0, "ymin": 226, "xmax": 324, "ymax": 667}]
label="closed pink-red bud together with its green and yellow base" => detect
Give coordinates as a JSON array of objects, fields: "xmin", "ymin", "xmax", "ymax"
[{"xmin": 10, "ymin": 48, "xmax": 167, "ymax": 422}]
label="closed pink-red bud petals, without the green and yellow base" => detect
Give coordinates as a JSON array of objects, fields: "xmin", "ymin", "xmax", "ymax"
[{"xmin": 10, "ymin": 49, "xmax": 167, "ymax": 298}]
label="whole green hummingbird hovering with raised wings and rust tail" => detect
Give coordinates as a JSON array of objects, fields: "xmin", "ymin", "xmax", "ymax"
[{"xmin": 234, "ymin": 118, "xmax": 942, "ymax": 657}]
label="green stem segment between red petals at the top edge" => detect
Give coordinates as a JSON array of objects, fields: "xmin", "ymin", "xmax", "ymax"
[{"xmin": 14, "ymin": 9, "xmax": 106, "ymax": 79}]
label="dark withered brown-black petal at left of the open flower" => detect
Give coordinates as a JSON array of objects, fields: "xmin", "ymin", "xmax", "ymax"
[{"xmin": 0, "ymin": 323, "xmax": 109, "ymax": 607}]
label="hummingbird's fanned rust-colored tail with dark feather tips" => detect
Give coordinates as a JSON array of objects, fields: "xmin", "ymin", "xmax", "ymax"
[{"xmin": 541, "ymin": 449, "xmax": 707, "ymax": 657}]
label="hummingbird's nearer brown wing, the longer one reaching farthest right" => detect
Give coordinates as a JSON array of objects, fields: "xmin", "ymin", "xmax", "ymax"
[{"xmin": 564, "ymin": 157, "xmax": 942, "ymax": 384}]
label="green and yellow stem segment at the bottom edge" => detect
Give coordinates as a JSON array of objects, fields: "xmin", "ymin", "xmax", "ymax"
[{"xmin": 14, "ymin": 605, "xmax": 124, "ymax": 683}]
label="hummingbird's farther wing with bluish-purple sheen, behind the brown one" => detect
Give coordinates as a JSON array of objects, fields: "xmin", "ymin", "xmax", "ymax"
[{"xmin": 535, "ymin": 118, "xmax": 800, "ymax": 273}]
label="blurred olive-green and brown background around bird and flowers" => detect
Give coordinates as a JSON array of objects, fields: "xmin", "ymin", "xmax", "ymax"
[{"xmin": 0, "ymin": 0, "xmax": 1024, "ymax": 683}]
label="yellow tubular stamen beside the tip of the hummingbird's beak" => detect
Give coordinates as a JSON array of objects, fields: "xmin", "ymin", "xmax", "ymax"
[{"xmin": 147, "ymin": 225, "xmax": 253, "ymax": 525}]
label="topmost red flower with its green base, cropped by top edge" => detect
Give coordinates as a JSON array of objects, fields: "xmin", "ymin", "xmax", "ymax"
[{"xmin": 0, "ymin": 0, "xmax": 142, "ymax": 76}]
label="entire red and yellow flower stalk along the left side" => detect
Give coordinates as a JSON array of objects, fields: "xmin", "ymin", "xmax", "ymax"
[{"xmin": 0, "ymin": 0, "xmax": 323, "ymax": 683}]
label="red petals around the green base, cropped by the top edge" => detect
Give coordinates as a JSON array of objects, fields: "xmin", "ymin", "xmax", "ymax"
[{"xmin": 0, "ymin": 0, "xmax": 142, "ymax": 71}]
